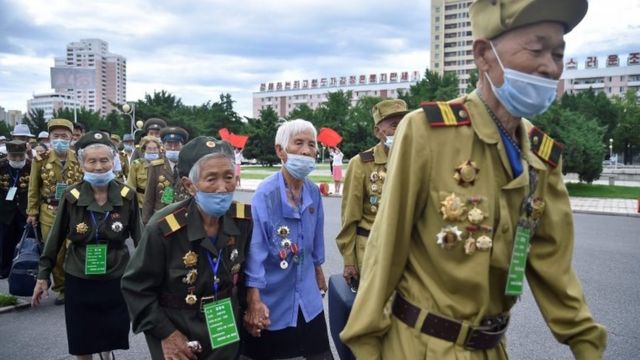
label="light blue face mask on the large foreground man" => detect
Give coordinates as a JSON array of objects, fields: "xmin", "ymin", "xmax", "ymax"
[{"xmin": 485, "ymin": 43, "xmax": 558, "ymax": 118}]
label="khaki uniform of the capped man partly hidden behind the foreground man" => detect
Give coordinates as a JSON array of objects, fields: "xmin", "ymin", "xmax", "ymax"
[{"xmin": 336, "ymin": 143, "xmax": 387, "ymax": 271}]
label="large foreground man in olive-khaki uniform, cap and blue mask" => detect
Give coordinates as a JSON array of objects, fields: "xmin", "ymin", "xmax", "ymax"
[{"xmin": 341, "ymin": 0, "xmax": 607, "ymax": 360}]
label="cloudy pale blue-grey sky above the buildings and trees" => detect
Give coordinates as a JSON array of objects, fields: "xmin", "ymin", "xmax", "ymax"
[{"xmin": 0, "ymin": 0, "xmax": 640, "ymax": 116}]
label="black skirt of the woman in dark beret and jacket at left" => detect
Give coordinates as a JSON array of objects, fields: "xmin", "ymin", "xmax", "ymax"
[{"xmin": 64, "ymin": 273, "xmax": 129, "ymax": 355}]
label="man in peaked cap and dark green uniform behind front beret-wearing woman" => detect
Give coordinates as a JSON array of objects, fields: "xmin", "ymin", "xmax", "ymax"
[{"xmin": 142, "ymin": 127, "xmax": 189, "ymax": 224}]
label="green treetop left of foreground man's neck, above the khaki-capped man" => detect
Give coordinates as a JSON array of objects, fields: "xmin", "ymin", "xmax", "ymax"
[{"xmin": 399, "ymin": 69, "xmax": 458, "ymax": 109}]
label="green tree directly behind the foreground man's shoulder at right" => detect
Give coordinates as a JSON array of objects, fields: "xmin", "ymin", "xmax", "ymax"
[{"xmin": 533, "ymin": 104, "xmax": 604, "ymax": 183}]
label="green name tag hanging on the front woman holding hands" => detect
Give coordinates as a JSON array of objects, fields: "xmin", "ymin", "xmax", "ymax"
[{"xmin": 204, "ymin": 298, "xmax": 240, "ymax": 349}]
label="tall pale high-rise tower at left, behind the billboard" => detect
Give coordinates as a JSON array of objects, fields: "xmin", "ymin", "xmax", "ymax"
[{"xmin": 55, "ymin": 39, "xmax": 127, "ymax": 116}]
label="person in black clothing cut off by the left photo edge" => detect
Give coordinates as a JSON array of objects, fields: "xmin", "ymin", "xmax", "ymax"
[{"xmin": 0, "ymin": 140, "xmax": 31, "ymax": 279}]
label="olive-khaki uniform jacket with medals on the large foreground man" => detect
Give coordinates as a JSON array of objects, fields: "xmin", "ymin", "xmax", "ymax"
[{"xmin": 341, "ymin": 93, "xmax": 607, "ymax": 359}]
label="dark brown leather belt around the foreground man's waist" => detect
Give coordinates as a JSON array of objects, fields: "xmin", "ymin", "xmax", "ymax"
[{"xmin": 392, "ymin": 293, "xmax": 509, "ymax": 350}]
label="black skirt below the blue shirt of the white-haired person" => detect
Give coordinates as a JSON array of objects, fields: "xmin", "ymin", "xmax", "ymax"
[{"xmin": 241, "ymin": 310, "xmax": 332, "ymax": 360}]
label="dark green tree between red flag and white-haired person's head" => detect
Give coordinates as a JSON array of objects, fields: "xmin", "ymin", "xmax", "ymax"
[{"xmin": 243, "ymin": 107, "xmax": 280, "ymax": 166}]
